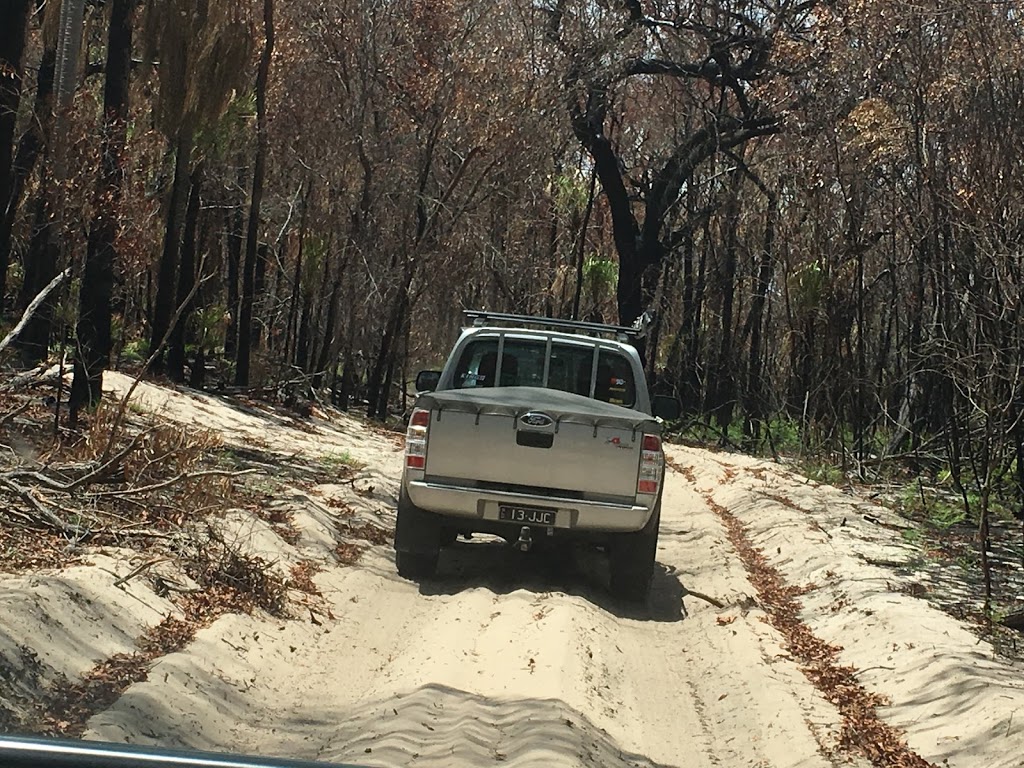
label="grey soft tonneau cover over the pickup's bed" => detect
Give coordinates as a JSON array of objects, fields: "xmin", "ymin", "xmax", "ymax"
[{"xmin": 416, "ymin": 387, "xmax": 662, "ymax": 434}]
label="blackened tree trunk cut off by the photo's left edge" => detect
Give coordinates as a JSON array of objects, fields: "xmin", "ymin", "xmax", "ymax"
[{"xmin": 0, "ymin": 0, "xmax": 32, "ymax": 316}]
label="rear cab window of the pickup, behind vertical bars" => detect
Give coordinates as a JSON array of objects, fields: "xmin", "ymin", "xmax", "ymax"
[{"xmin": 454, "ymin": 337, "xmax": 636, "ymax": 408}]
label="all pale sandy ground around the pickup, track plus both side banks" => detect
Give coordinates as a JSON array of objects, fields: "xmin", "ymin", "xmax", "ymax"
[{"xmin": 8, "ymin": 385, "xmax": 1024, "ymax": 768}]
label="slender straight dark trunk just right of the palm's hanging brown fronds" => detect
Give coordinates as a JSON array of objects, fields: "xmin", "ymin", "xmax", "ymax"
[{"xmin": 234, "ymin": 0, "xmax": 273, "ymax": 386}]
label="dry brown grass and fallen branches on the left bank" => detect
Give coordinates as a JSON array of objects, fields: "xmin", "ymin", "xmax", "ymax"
[{"xmin": 0, "ymin": 396, "xmax": 234, "ymax": 570}]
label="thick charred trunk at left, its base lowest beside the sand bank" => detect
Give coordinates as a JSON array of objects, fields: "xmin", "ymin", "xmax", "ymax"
[{"xmin": 70, "ymin": 0, "xmax": 135, "ymax": 424}]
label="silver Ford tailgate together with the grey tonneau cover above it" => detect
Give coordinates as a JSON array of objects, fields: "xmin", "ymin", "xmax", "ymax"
[{"xmin": 417, "ymin": 387, "xmax": 660, "ymax": 500}]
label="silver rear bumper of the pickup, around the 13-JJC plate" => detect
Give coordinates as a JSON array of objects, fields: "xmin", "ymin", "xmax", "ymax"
[{"xmin": 406, "ymin": 478, "xmax": 654, "ymax": 532}]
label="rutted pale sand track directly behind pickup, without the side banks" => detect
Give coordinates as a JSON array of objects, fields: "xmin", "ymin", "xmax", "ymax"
[{"xmin": 79, "ymin": 450, "xmax": 836, "ymax": 768}]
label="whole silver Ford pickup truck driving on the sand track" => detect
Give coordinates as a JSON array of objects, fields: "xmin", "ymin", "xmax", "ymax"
[{"xmin": 395, "ymin": 311, "xmax": 679, "ymax": 601}]
